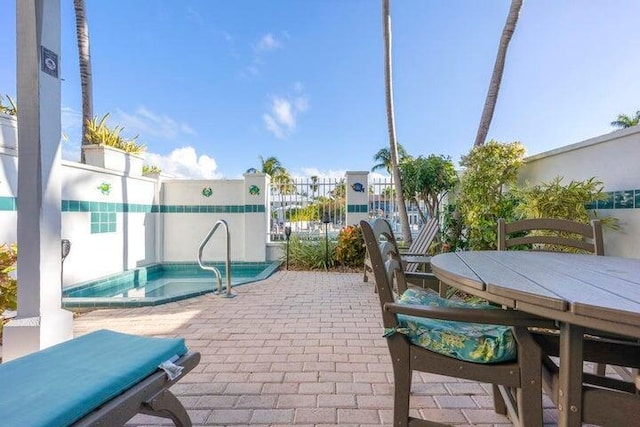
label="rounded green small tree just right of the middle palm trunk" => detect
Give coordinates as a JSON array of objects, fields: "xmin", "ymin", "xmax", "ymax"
[{"xmin": 400, "ymin": 154, "xmax": 458, "ymax": 221}]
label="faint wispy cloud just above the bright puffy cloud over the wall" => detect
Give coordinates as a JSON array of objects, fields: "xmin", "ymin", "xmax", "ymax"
[{"xmin": 112, "ymin": 106, "xmax": 196, "ymax": 142}]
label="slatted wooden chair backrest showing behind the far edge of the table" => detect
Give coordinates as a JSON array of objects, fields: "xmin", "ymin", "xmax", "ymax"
[{"xmin": 498, "ymin": 218, "xmax": 604, "ymax": 255}]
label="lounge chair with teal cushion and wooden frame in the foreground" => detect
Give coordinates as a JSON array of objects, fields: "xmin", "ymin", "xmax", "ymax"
[{"xmin": 0, "ymin": 330, "xmax": 200, "ymax": 426}]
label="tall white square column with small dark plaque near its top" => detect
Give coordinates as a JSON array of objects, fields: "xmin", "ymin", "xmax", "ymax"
[{"xmin": 2, "ymin": 0, "xmax": 73, "ymax": 361}]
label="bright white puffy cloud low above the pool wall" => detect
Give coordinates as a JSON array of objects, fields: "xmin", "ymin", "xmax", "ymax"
[{"xmin": 145, "ymin": 146, "xmax": 222, "ymax": 179}]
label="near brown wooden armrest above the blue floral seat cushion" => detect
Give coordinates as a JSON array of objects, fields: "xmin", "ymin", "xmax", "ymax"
[{"xmin": 384, "ymin": 303, "xmax": 555, "ymax": 328}]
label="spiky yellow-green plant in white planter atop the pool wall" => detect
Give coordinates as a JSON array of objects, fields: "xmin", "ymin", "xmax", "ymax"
[{"xmin": 82, "ymin": 113, "xmax": 147, "ymax": 176}]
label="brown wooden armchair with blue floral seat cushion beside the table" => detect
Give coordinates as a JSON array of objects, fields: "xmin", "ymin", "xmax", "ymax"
[{"xmin": 360, "ymin": 219, "xmax": 552, "ymax": 426}]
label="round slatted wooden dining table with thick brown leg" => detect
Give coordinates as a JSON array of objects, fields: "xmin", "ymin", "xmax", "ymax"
[{"xmin": 431, "ymin": 251, "xmax": 640, "ymax": 427}]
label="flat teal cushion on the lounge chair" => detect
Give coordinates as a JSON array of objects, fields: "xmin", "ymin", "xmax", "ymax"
[{"xmin": 0, "ymin": 330, "xmax": 187, "ymax": 426}]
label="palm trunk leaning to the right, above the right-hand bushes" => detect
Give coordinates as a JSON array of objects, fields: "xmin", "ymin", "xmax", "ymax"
[{"xmin": 474, "ymin": 0, "xmax": 523, "ymax": 146}]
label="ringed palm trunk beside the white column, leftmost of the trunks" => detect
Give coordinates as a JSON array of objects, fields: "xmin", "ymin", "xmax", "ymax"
[{"xmin": 73, "ymin": 0, "xmax": 93, "ymax": 163}]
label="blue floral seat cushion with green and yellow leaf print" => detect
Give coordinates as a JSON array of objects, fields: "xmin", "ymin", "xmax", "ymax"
[{"xmin": 384, "ymin": 288, "xmax": 517, "ymax": 363}]
